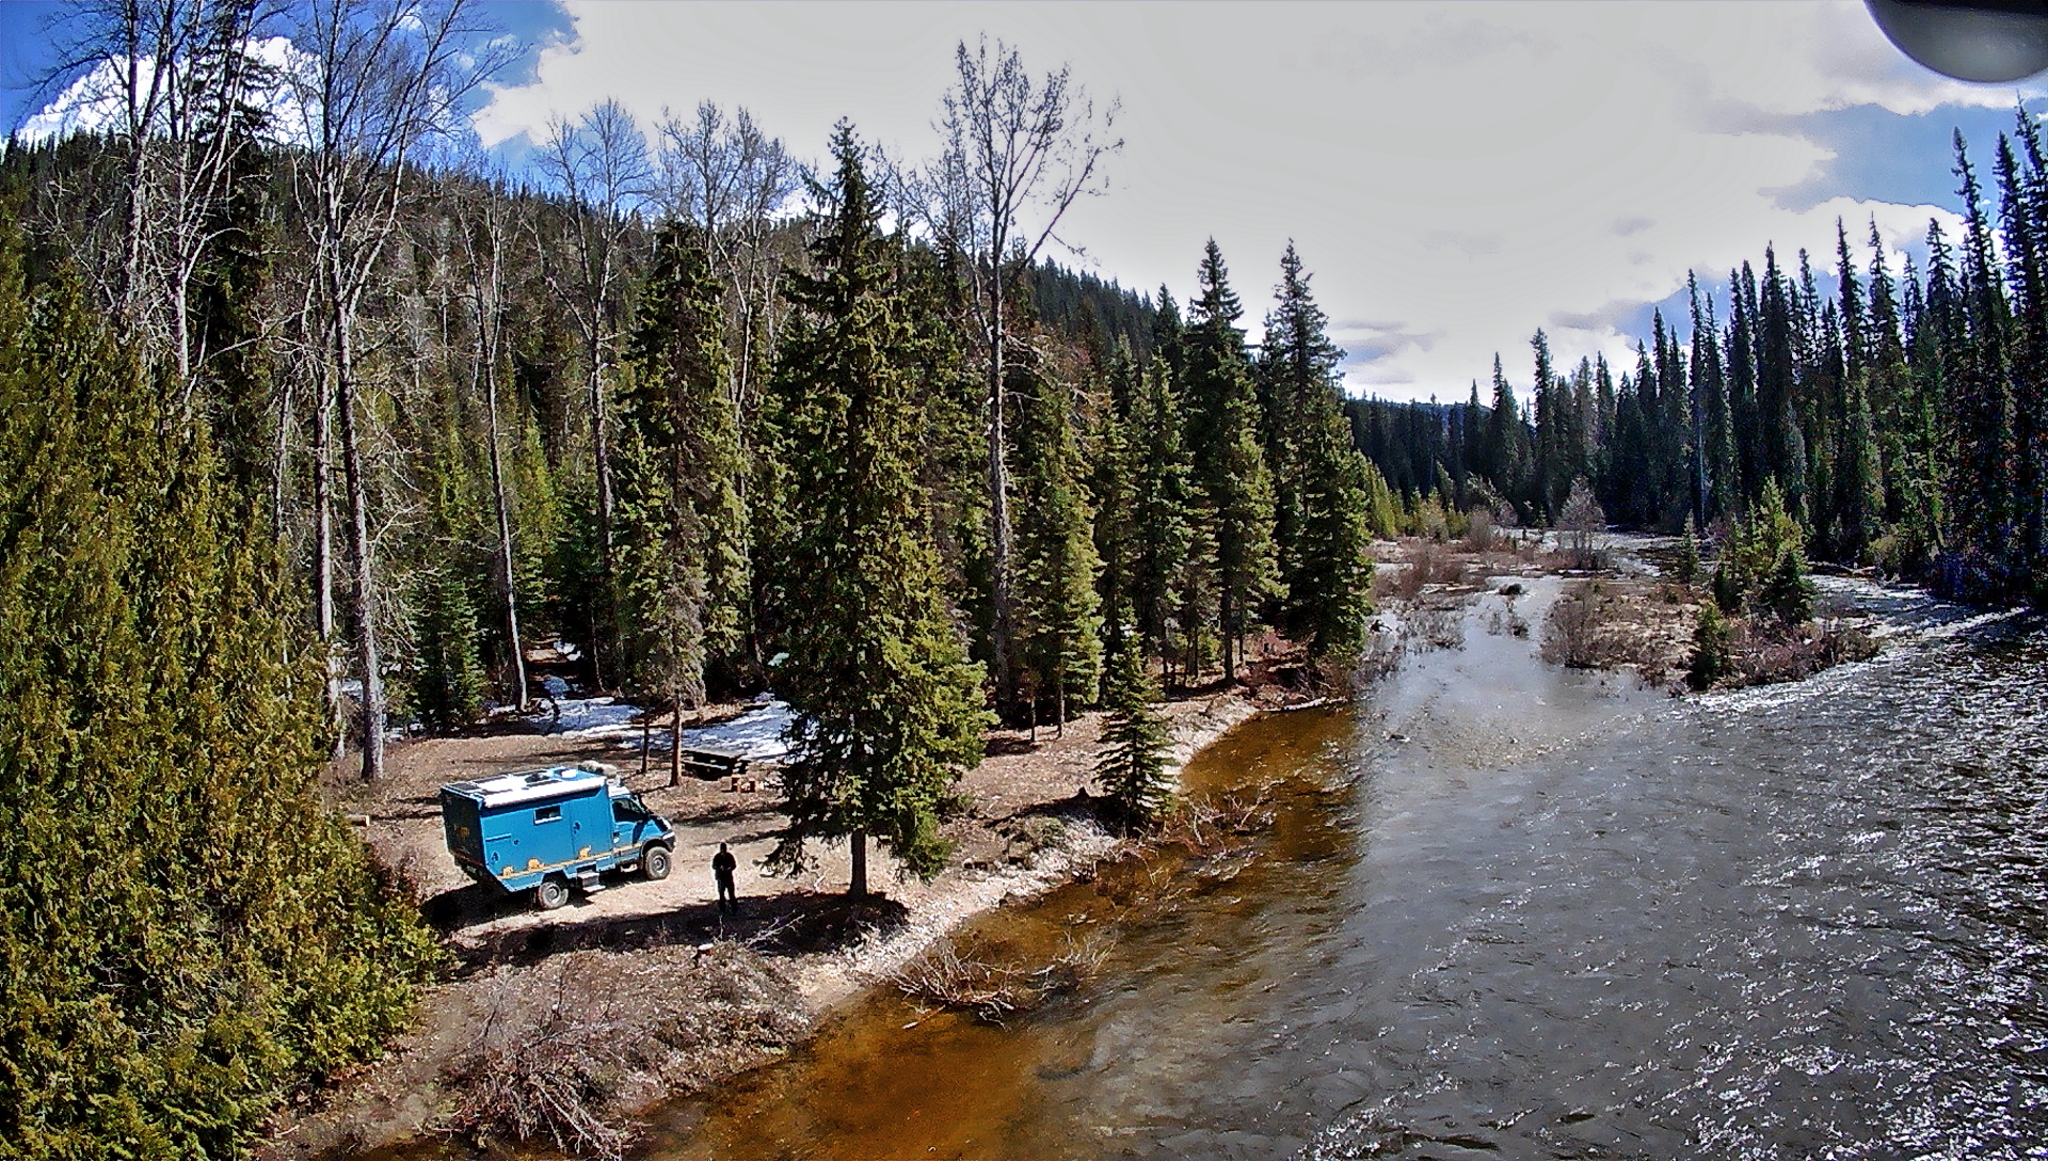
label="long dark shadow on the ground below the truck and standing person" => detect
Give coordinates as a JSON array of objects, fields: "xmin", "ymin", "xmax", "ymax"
[{"xmin": 422, "ymin": 885, "xmax": 909, "ymax": 977}]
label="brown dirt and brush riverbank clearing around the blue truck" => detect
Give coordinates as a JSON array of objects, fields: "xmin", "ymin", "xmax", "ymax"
[{"xmin": 256, "ymin": 692, "xmax": 1260, "ymax": 1161}]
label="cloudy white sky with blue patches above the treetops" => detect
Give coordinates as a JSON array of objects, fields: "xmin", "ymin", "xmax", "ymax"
[{"xmin": 0, "ymin": 0, "xmax": 2048, "ymax": 399}]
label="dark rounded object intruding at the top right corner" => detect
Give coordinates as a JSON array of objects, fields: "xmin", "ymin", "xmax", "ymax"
[{"xmin": 1864, "ymin": 0, "xmax": 2048, "ymax": 84}]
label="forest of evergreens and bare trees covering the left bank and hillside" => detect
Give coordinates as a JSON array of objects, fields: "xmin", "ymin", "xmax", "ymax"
[{"xmin": 0, "ymin": 2, "xmax": 1391, "ymax": 1157}]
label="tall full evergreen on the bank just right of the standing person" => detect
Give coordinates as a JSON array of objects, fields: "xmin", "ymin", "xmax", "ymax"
[{"xmin": 770, "ymin": 121, "xmax": 989, "ymax": 895}]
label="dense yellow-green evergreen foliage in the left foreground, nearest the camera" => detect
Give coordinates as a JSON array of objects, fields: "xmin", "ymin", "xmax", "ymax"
[{"xmin": 0, "ymin": 225, "xmax": 438, "ymax": 1159}]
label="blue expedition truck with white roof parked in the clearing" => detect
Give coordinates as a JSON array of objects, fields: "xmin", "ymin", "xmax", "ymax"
[{"xmin": 440, "ymin": 764, "xmax": 676, "ymax": 911}]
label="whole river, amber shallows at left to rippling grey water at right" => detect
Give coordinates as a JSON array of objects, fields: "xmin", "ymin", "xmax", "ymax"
[{"xmin": 645, "ymin": 582, "xmax": 2048, "ymax": 1157}]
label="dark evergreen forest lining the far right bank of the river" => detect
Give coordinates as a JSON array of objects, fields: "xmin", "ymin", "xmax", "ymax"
[{"xmin": 1350, "ymin": 113, "xmax": 2048, "ymax": 602}]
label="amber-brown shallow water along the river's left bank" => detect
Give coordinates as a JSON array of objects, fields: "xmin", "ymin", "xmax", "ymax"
[{"xmin": 645, "ymin": 711, "xmax": 1352, "ymax": 1157}]
